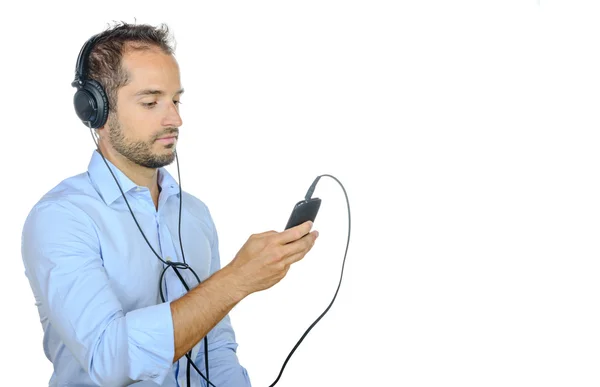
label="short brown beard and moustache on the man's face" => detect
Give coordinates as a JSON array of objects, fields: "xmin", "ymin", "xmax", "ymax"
[{"xmin": 108, "ymin": 113, "xmax": 177, "ymax": 169}]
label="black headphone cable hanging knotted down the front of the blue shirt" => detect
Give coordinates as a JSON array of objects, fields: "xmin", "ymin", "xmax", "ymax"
[{"xmin": 88, "ymin": 126, "xmax": 211, "ymax": 387}]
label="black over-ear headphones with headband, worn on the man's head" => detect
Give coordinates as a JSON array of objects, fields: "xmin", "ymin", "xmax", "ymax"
[{"xmin": 71, "ymin": 35, "xmax": 108, "ymax": 129}]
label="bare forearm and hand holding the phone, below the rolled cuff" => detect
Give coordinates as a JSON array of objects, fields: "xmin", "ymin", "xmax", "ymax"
[{"xmin": 171, "ymin": 221, "xmax": 319, "ymax": 362}]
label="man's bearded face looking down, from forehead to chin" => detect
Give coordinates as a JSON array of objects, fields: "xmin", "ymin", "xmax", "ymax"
[{"xmin": 106, "ymin": 44, "xmax": 183, "ymax": 168}]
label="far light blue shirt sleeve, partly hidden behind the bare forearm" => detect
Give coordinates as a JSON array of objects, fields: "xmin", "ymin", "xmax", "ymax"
[{"xmin": 196, "ymin": 212, "xmax": 251, "ymax": 387}]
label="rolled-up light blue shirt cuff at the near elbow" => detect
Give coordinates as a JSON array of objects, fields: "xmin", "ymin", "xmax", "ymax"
[{"xmin": 126, "ymin": 302, "xmax": 175, "ymax": 385}]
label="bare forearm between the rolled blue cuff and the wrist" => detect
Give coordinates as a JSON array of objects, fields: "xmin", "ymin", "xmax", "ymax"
[{"xmin": 171, "ymin": 267, "xmax": 247, "ymax": 362}]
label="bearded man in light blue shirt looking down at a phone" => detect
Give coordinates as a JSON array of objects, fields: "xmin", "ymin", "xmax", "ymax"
[{"xmin": 22, "ymin": 23, "xmax": 318, "ymax": 387}]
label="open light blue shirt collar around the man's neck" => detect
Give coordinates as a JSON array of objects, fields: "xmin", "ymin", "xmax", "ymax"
[{"xmin": 88, "ymin": 149, "xmax": 179, "ymax": 206}]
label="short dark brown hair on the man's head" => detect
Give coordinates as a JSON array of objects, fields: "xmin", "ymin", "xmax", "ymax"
[{"xmin": 87, "ymin": 22, "xmax": 175, "ymax": 112}]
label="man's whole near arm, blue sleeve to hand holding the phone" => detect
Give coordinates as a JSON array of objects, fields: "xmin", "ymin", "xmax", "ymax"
[{"xmin": 22, "ymin": 202, "xmax": 318, "ymax": 385}]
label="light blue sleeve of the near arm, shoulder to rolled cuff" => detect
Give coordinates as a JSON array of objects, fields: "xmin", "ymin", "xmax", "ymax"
[{"xmin": 21, "ymin": 202, "xmax": 175, "ymax": 386}]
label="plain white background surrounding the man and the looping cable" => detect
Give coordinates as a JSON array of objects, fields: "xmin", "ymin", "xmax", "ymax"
[{"xmin": 0, "ymin": 0, "xmax": 600, "ymax": 387}]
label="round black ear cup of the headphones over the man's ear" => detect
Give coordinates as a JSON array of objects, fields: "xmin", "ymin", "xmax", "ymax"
[{"xmin": 73, "ymin": 79, "xmax": 108, "ymax": 129}]
